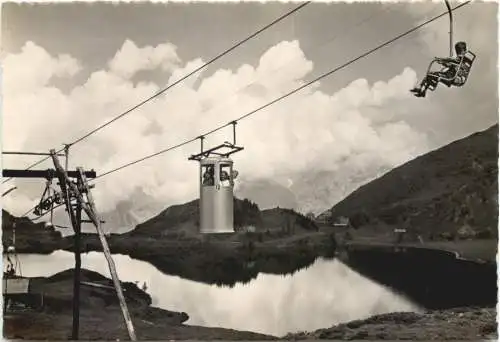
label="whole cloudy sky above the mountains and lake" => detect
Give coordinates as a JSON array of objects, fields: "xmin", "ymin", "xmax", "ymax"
[{"xmin": 1, "ymin": 2, "xmax": 498, "ymax": 223}]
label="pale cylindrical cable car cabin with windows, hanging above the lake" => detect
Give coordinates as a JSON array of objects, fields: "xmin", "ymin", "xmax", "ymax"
[{"xmin": 200, "ymin": 156, "xmax": 237, "ymax": 234}]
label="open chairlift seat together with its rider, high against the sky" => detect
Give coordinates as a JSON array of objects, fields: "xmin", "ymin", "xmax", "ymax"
[{"xmin": 411, "ymin": 42, "xmax": 476, "ymax": 97}]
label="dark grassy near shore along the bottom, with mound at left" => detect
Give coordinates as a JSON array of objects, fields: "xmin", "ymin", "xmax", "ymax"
[{"xmin": 4, "ymin": 269, "xmax": 496, "ymax": 341}]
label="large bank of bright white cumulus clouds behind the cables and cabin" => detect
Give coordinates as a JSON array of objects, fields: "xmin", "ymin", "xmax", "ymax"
[{"xmin": 3, "ymin": 36, "xmax": 427, "ymax": 219}]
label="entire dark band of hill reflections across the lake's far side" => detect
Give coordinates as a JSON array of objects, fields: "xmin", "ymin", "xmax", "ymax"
[{"xmin": 4, "ymin": 232, "xmax": 497, "ymax": 309}]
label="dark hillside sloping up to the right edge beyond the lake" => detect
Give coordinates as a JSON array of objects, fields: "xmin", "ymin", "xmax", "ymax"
[{"xmin": 331, "ymin": 124, "xmax": 498, "ymax": 240}]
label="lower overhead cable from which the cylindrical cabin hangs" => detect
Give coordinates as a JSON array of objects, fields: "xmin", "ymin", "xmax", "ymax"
[{"xmin": 94, "ymin": 0, "xmax": 470, "ymax": 180}]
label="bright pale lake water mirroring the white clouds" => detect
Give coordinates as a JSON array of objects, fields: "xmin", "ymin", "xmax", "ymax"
[{"xmin": 9, "ymin": 251, "xmax": 417, "ymax": 336}]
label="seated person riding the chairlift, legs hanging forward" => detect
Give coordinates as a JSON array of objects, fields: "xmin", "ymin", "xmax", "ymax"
[{"xmin": 410, "ymin": 42, "xmax": 467, "ymax": 97}]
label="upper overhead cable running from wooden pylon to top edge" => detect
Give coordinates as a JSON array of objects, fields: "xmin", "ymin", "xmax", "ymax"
[{"xmin": 2, "ymin": 1, "xmax": 311, "ymax": 184}]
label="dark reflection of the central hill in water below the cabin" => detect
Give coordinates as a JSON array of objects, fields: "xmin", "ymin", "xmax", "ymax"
[{"xmin": 67, "ymin": 232, "xmax": 335, "ymax": 285}]
